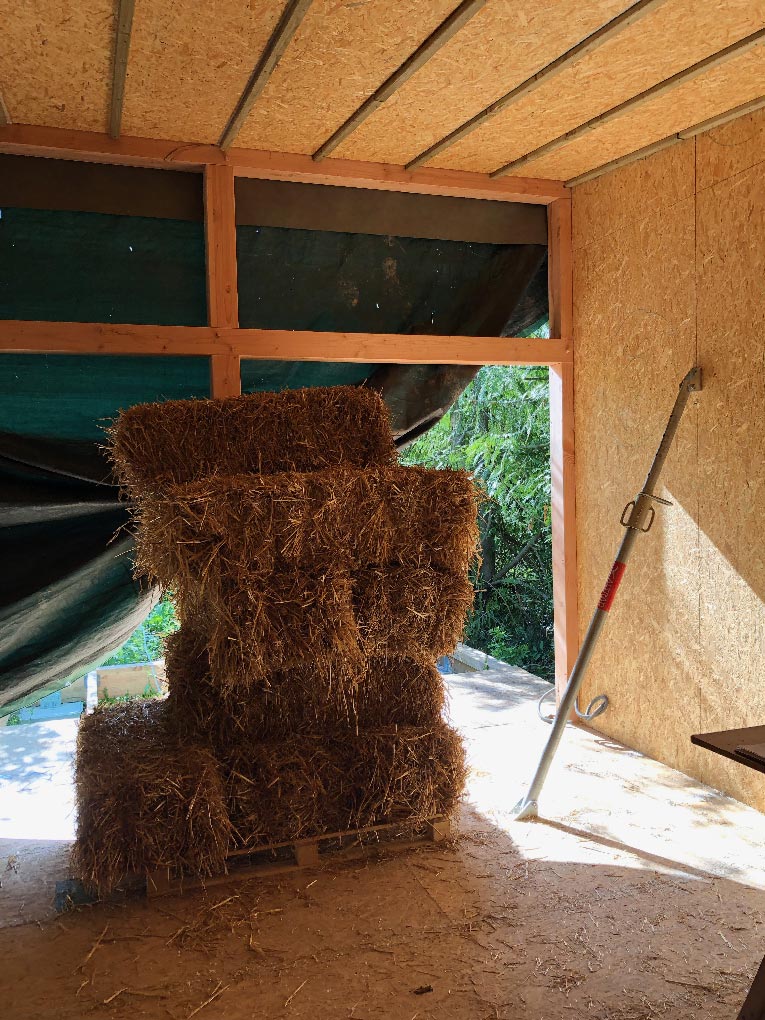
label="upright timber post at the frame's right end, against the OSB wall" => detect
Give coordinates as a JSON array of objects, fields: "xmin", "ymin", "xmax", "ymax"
[{"xmin": 548, "ymin": 199, "xmax": 579, "ymax": 701}]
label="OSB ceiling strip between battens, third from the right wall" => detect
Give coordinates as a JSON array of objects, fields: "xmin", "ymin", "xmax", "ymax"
[{"xmin": 335, "ymin": 0, "xmax": 629, "ymax": 163}]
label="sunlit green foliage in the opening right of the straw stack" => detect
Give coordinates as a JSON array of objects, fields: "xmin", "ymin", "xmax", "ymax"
[{"xmin": 401, "ymin": 367, "xmax": 554, "ymax": 679}]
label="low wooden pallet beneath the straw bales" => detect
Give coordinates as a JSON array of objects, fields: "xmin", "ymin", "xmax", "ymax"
[{"xmin": 146, "ymin": 816, "xmax": 452, "ymax": 899}]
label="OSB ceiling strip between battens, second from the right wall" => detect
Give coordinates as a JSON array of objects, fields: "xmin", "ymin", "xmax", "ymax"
[{"xmin": 429, "ymin": 0, "xmax": 765, "ymax": 173}]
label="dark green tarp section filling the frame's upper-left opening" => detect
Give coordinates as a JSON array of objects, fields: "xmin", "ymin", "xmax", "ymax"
[{"xmin": 0, "ymin": 208, "xmax": 207, "ymax": 325}]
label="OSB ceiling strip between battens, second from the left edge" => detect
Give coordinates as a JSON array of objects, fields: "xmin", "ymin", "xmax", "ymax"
[{"xmin": 122, "ymin": 0, "xmax": 287, "ymax": 144}]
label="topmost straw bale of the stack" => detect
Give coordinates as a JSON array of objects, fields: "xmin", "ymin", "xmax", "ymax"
[{"xmin": 108, "ymin": 387, "xmax": 396, "ymax": 499}]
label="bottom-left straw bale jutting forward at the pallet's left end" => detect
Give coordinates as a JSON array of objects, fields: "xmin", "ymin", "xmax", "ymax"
[{"xmin": 71, "ymin": 701, "xmax": 231, "ymax": 893}]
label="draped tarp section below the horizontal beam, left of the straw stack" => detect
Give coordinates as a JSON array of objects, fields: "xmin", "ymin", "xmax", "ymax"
[{"xmin": 0, "ymin": 346, "xmax": 210, "ymax": 713}]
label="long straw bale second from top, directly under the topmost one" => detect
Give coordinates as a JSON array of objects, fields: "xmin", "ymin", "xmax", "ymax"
[{"xmin": 131, "ymin": 467, "xmax": 478, "ymax": 592}]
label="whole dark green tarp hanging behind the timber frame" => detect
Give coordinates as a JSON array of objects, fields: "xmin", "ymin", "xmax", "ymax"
[{"xmin": 0, "ymin": 209, "xmax": 547, "ymax": 712}]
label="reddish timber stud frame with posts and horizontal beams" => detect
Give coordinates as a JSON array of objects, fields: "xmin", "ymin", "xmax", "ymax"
[{"xmin": 0, "ymin": 143, "xmax": 578, "ymax": 698}]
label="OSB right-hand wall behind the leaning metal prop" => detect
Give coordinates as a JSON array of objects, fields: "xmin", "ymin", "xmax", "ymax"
[{"xmin": 573, "ymin": 116, "xmax": 765, "ymax": 810}]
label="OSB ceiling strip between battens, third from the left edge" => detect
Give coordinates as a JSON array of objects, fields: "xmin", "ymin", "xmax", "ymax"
[{"xmin": 235, "ymin": 0, "xmax": 461, "ymax": 155}]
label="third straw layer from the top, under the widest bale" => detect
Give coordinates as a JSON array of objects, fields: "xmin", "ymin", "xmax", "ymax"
[{"xmin": 171, "ymin": 565, "xmax": 473, "ymax": 691}]
